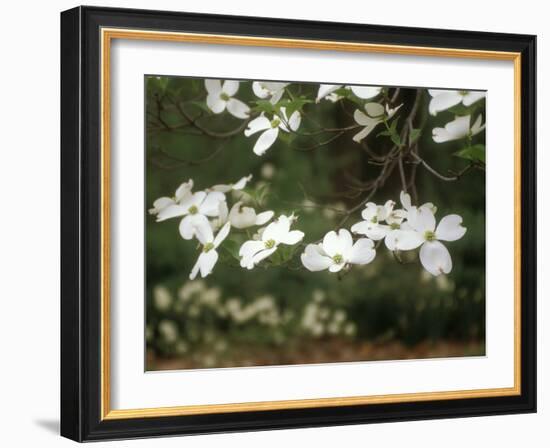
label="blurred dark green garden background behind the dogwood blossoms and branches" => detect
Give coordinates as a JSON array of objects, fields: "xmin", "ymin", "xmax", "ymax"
[{"xmin": 144, "ymin": 76, "xmax": 485, "ymax": 370}]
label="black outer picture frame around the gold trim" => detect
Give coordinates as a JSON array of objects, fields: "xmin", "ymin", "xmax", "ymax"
[{"xmin": 61, "ymin": 7, "xmax": 537, "ymax": 441}]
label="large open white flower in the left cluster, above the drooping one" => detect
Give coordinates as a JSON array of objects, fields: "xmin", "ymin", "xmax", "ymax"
[{"xmin": 157, "ymin": 191, "xmax": 225, "ymax": 240}]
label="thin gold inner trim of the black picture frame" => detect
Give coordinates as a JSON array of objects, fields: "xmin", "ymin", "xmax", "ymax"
[{"xmin": 100, "ymin": 28, "xmax": 521, "ymax": 420}]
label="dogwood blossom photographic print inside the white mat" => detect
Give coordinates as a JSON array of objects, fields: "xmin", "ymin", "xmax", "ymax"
[{"xmin": 144, "ymin": 75, "xmax": 486, "ymax": 370}]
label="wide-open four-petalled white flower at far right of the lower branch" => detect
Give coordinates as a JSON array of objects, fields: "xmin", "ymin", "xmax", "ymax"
[{"xmin": 395, "ymin": 207, "xmax": 466, "ymax": 276}]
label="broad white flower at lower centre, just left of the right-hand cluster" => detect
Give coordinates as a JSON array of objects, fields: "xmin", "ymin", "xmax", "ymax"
[{"xmin": 301, "ymin": 229, "xmax": 376, "ymax": 272}]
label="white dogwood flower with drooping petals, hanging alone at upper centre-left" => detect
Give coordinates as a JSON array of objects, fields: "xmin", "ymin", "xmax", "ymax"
[{"xmin": 244, "ymin": 107, "xmax": 302, "ymax": 156}]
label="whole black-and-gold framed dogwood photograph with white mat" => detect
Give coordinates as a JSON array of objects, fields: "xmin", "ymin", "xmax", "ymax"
[{"xmin": 61, "ymin": 7, "xmax": 536, "ymax": 441}]
